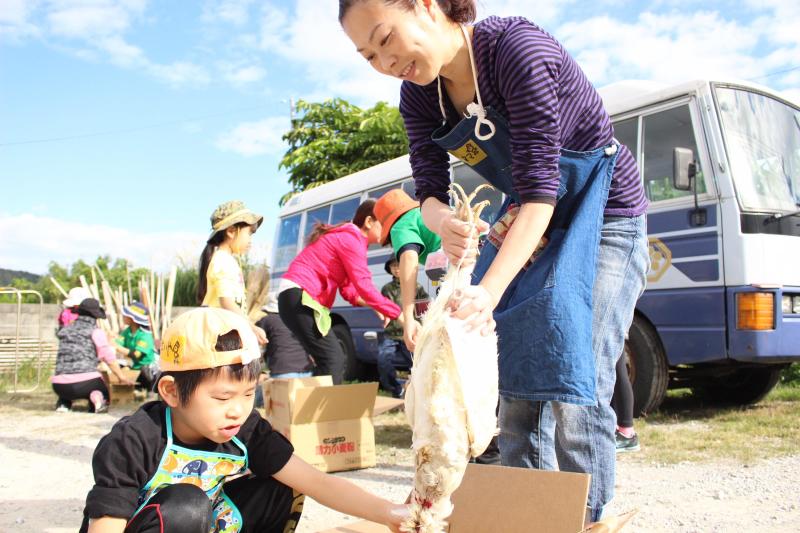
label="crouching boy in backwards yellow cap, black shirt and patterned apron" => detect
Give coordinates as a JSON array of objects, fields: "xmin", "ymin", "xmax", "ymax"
[{"xmin": 81, "ymin": 307, "xmax": 406, "ymax": 533}]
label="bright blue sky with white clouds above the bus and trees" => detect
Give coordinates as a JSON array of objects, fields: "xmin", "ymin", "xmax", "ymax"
[{"xmin": 0, "ymin": 0, "xmax": 800, "ymax": 273}]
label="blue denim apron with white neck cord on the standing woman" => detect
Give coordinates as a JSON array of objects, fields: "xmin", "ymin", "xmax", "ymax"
[{"xmin": 432, "ymin": 27, "xmax": 618, "ymax": 405}]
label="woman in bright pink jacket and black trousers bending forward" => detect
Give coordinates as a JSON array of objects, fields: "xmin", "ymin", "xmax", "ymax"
[{"xmin": 278, "ymin": 199, "xmax": 400, "ymax": 385}]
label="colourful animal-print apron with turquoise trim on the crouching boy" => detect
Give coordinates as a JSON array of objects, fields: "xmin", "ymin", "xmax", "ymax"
[{"xmin": 134, "ymin": 407, "xmax": 247, "ymax": 533}]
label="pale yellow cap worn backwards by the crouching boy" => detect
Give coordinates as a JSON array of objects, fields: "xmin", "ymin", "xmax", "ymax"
[{"xmin": 159, "ymin": 307, "xmax": 261, "ymax": 372}]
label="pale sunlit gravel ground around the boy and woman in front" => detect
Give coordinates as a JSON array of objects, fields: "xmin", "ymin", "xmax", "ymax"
[{"xmin": 0, "ymin": 405, "xmax": 800, "ymax": 533}]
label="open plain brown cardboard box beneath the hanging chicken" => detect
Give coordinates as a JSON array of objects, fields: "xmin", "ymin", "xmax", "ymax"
[{"xmin": 321, "ymin": 464, "xmax": 590, "ymax": 533}]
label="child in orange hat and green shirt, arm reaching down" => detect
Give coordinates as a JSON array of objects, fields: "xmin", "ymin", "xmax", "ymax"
[{"xmin": 375, "ymin": 189, "xmax": 442, "ymax": 352}]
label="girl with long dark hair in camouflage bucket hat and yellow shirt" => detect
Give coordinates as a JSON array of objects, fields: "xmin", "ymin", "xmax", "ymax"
[{"xmin": 197, "ymin": 200, "xmax": 267, "ymax": 345}]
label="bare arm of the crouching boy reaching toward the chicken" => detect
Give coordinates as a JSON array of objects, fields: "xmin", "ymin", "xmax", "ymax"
[{"xmin": 273, "ymin": 455, "xmax": 408, "ymax": 532}]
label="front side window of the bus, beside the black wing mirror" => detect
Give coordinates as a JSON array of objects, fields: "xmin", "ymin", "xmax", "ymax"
[{"xmin": 641, "ymin": 105, "xmax": 706, "ymax": 202}]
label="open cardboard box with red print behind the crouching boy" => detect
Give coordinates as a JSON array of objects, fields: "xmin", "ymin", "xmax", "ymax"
[{"xmin": 264, "ymin": 376, "xmax": 378, "ymax": 472}]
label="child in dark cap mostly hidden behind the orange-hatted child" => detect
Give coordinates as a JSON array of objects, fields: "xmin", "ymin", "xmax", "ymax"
[{"xmin": 378, "ymin": 257, "xmax": 428, "ymax": 398}]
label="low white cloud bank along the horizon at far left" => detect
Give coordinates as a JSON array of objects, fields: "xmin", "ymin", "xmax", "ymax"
[{"xmin": 0, "ymin": 213, "xmax": 208, "ymax": 273}]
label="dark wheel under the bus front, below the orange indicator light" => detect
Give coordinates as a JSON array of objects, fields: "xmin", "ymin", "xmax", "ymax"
[{"xmin": 692, "ymin": 365, "xmax": 784, "ymax": 405}]
